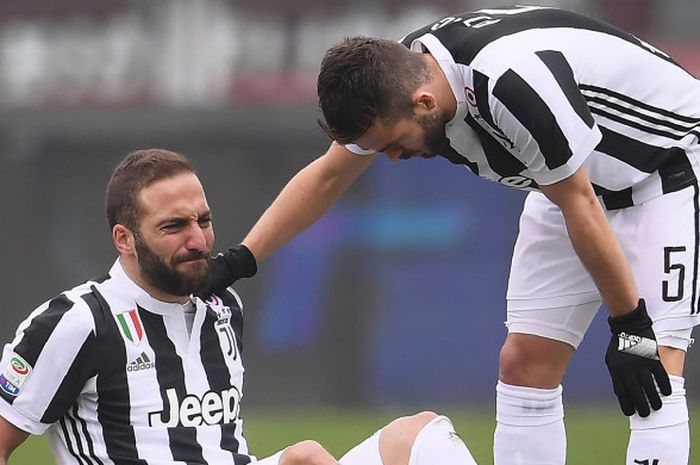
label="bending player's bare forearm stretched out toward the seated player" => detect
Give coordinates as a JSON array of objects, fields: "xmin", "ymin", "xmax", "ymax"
[{"xmin": 243, "ymin": 142, "xmax": 377, "ymax": 260}]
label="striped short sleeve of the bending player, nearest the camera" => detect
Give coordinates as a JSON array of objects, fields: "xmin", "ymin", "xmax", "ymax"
[{"xmin": 482, "ymin": 50, "xmax": 602, "ymax": 185}]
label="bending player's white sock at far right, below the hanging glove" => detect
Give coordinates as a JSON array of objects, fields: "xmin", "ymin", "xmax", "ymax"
[{"xmin": 625, "ymin": 376, "xmax": 690, "ymax": 465}]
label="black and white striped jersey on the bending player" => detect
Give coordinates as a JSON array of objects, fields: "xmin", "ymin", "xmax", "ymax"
[{"xmin": 349, "ymin": 7, "xmax": 700, "ymax": 208}]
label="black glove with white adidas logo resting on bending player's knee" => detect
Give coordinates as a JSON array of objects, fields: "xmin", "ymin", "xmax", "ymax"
[{"xmin": 605, "ymin": 299, "xmax": 671, "ymax": 417}]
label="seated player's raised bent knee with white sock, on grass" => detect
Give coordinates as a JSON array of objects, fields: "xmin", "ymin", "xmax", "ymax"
[{"xmin": 339, "ymin": 412, "xmax": 476, "ymax": 465}]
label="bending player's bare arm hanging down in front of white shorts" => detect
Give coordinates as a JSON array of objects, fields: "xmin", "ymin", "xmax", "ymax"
[{"xmin": 540, "ymin": 168, "xmax": 639, "ymax": 317}]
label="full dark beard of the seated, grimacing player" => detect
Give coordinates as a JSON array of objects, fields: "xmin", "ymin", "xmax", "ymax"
[{"xmin": 134, "ymin": 234, "xmax": 211, "ymax": 296}]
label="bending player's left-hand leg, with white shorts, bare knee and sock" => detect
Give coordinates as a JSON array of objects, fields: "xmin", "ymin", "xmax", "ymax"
[{"xmin": 504, "ymin": 192, "xmax": 601, "ymax": 465}]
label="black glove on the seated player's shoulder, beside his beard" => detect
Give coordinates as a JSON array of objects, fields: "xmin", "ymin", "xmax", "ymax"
[{"xmin": 195, "ymin": 244, "xmax": 258, "ymax": 300}]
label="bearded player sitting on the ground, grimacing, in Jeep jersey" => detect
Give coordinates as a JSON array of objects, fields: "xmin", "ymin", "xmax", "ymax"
[{"xmin": 0, "ymin": 149, "xmax": 476, "ymax": 465}]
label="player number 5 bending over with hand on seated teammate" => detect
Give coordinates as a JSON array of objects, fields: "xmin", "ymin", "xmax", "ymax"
[{"xmin": 208, "ymin": 6, "xmax": 700, "ymax": 465}]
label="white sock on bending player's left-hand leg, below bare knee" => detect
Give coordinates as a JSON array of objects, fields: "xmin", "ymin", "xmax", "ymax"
[{"xmin": 493, "ymin": 381, "xmax": 568, "ymax": 465}]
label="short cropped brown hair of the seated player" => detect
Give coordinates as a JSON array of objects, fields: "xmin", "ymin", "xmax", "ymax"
[{"xmin": 105, "ymin": 149, "xmax": 195, "ymax": 232}]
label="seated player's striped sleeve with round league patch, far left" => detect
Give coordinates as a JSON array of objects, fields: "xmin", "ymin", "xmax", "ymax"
[{"xmin": 0, "ymin": 294, "xmax": 96, "ymax": 434}]
